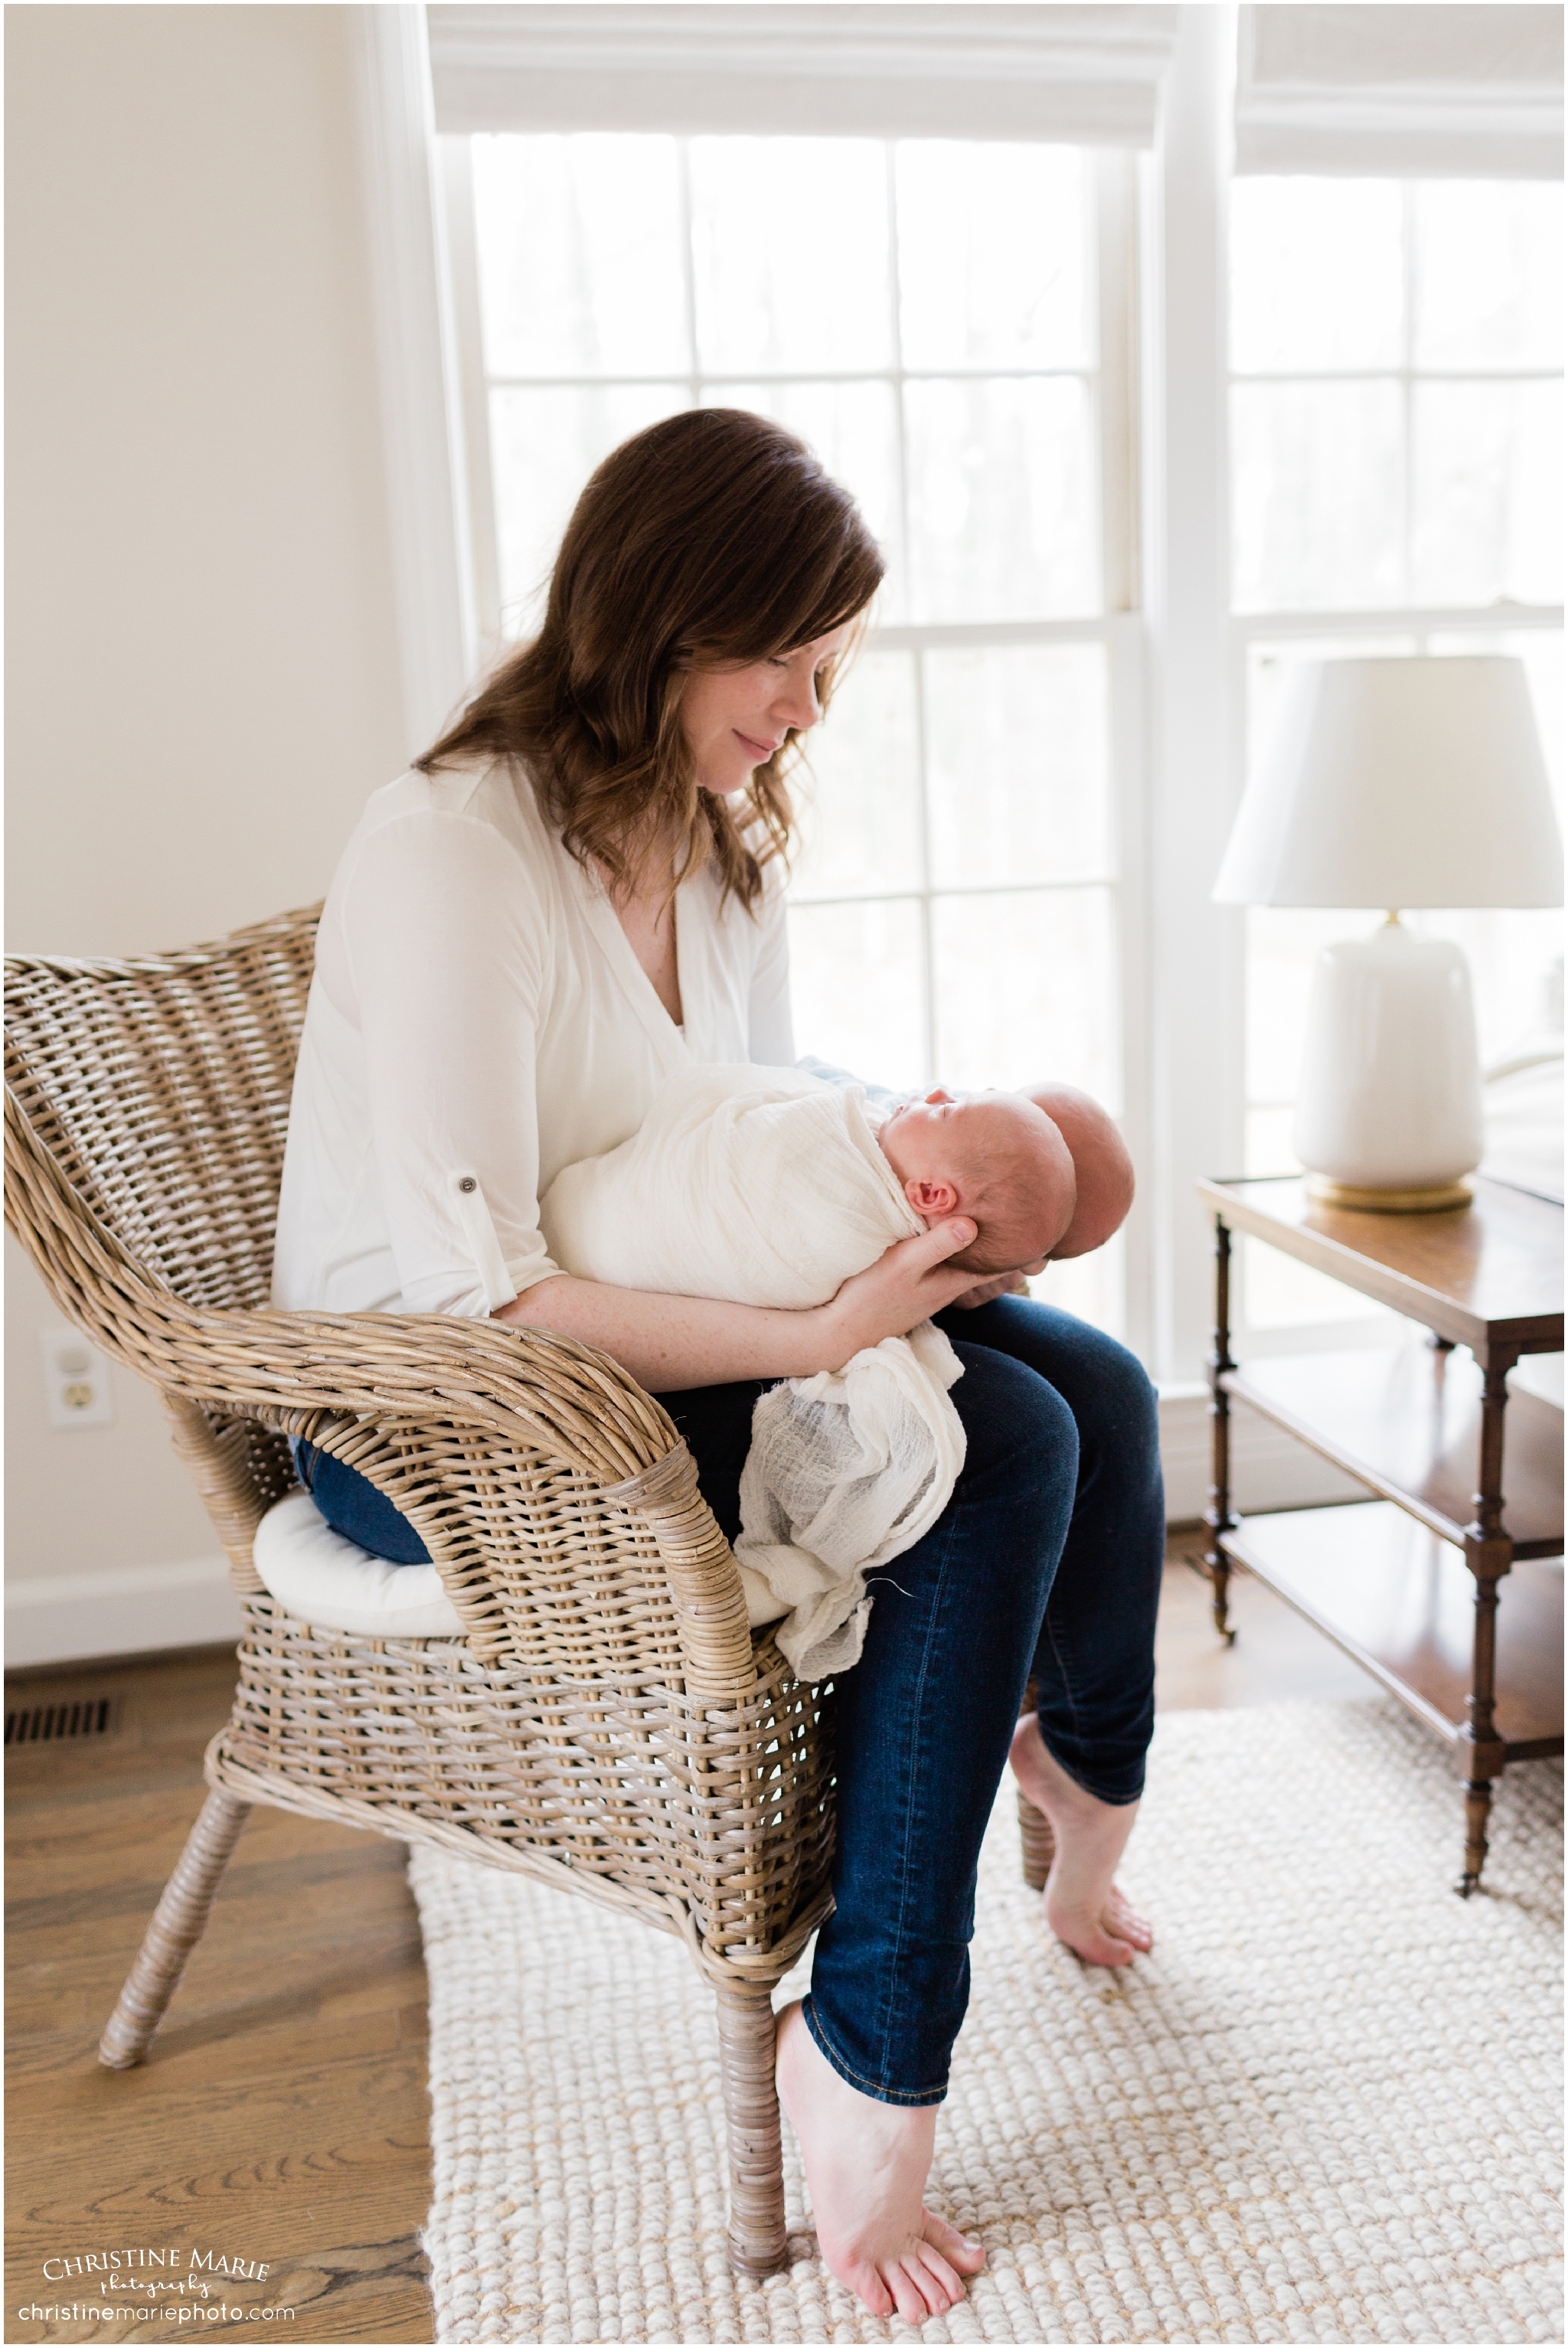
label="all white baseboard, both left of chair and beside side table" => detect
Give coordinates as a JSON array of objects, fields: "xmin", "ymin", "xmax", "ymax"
[{"xmin": 5, "ymin": 1386, "xmax": 1366, "ymax": 1670}]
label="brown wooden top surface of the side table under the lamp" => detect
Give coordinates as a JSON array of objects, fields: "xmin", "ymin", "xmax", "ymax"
[{"xmin": 1197, "ymin": 1174, "xmax": 1563, "ymax": 1357}]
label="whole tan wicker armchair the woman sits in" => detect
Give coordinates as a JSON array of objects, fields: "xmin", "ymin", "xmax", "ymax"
[{"xmin": 5, "ymin": 909, "xmax": 833, "ymax": 2273}]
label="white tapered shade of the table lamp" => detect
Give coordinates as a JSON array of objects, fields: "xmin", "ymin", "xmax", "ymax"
[{"xmin": 1214, "ymin": 655, "xmax": 1563, "ymax": 909}]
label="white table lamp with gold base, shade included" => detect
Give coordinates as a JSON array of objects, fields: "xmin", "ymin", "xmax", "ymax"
[{"xmin": 1214, "ymin": 655, "xmax": 1563, "ymax": 1212}]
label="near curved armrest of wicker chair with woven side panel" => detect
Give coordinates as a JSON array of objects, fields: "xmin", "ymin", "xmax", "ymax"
[{"xmin": 227, "ymin": 1312, "xmax": 753, "ymax": 1703}]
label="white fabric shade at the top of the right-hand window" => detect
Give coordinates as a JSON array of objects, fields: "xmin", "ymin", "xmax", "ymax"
[{"xmin": 1235, "ymin": 5, "xmax": 1563, "ymax": 178}]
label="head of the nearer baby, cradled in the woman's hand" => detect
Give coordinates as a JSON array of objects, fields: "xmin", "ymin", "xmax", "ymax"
[{"xmin": 878, "ymin": 1089, "xmax": 1077, "ymax": 1275}]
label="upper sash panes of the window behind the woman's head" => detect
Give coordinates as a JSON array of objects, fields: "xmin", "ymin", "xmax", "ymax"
[{"xmin": 469, "ymin": 134, "xmax": 1101, "ymax": 634}]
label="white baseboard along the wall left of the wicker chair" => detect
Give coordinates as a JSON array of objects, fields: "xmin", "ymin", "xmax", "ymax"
[{"xmin": 5, "ymin": 1556, "xmax": 240, "ymax": 1670}]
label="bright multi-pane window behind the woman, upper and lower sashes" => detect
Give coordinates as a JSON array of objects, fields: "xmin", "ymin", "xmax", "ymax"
[{"xmin": 449, "ymin": 134, "xmax": 1136, "ymax": 1327}]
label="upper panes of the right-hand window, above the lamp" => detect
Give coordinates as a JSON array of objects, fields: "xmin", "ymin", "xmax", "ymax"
[{"xmin": 1230, "ymin": 178, "xmax": 1563, "ymax": 612}]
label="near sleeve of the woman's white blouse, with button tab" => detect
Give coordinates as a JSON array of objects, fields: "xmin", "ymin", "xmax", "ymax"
[{"xmin": 343, "ymin": 808, "xmax": 559, "ymax": 1320}]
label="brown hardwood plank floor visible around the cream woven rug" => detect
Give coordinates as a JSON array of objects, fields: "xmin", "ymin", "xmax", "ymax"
[{"xmin": 5, "ymin": 1533, "xmax": 1370, "ymax": 2348}]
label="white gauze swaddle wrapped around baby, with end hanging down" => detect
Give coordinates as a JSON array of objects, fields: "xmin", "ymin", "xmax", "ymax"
[{"xmin": 540, "ymin": 1063, "xmax": 965, "ymax": 1679}]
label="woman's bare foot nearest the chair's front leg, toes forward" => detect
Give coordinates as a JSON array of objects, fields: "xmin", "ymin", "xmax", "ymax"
[{"xmin": 779, "ymin": 2003, "xmax": 986, "ymax": 2324}]
